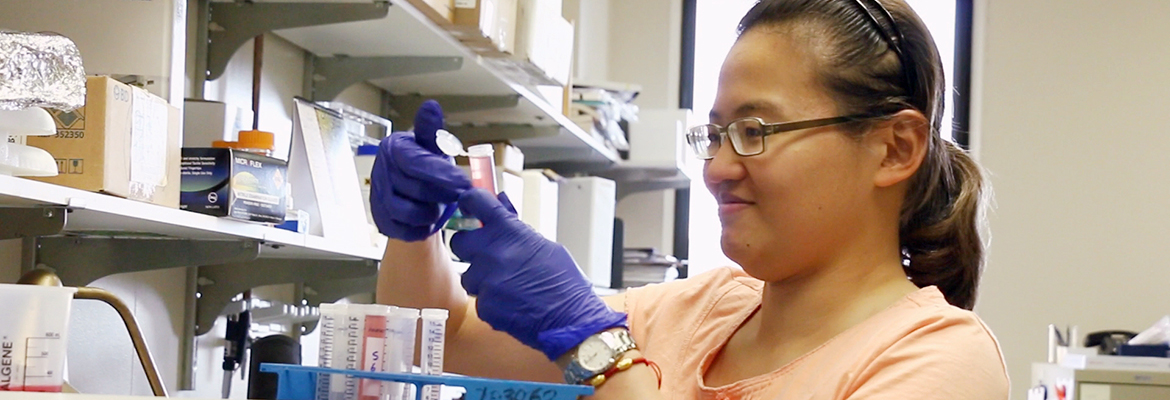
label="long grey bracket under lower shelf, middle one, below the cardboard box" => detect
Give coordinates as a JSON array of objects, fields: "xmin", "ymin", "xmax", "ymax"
[{"xmin": 36, "ymin": 236, "xmax": 261, "ymax": 287}]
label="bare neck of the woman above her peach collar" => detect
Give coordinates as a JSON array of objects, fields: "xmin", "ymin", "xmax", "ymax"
[{"xmin": 749, "ymin": 252, "xmax": 917, "ymax": 350}]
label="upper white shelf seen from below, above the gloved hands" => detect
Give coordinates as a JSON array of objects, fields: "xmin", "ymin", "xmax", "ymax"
[{"xmin": 256, "ymin": 0, "xmax": 621, "ymax": 167}]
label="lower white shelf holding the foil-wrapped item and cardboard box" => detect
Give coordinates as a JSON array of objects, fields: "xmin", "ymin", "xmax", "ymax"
[{"xmin": 0, "ymin": 175, "xmax": 385, "ymax": 260}]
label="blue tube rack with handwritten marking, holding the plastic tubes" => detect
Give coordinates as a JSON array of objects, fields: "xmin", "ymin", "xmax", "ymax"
[{"xmin": 260, "ymin": 364, "xmax": 593, "ymax": 400}]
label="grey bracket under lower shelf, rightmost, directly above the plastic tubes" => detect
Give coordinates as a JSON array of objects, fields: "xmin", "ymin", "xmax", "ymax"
[{"xmin": 195, "ymin": 258, "xmax": 378, "ymax": 336}]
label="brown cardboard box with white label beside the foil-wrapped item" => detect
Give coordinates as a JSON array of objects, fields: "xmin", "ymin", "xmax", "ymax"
[{"xmin": 27, "ymin": 76, "xmax": 183, "ymax": 208}]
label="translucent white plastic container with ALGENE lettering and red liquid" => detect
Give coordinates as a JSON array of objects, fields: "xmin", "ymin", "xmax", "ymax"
[{"xmin": 0, "ymin": 284, "xmax": 77, "ymax": 392}]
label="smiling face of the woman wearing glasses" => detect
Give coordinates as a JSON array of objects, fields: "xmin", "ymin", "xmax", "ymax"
[{"xmin": 703, "ymin": 28, "xmax": 880, "ymax": 282}]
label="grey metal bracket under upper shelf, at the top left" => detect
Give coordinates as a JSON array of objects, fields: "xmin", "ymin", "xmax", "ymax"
[{"xmin": 199, "ymin": 1, "xmax": 390, "ymax": 80}]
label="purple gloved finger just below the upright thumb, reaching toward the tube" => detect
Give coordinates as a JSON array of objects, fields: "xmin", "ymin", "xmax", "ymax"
[{"xmin": 383, "ymin": 132, "xmax": 472, "ymax": 193}]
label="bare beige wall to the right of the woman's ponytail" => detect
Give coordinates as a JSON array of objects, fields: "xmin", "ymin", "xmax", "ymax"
[{"xmin": 973, "ymin": 0, "xmax": 1170, "ymax": 399}]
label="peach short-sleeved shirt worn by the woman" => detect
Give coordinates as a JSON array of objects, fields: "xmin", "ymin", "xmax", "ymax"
[{"xmin": 626, "ymin": 268, "xmax": 1009, "ymax": 400}]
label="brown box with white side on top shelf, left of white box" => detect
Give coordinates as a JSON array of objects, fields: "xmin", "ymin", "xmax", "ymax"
[{"xmin": 452, "ymin": 0, "xmax": 517, "ymax": 55}]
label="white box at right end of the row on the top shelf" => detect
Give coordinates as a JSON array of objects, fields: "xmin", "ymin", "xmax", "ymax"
[{"xmin": 515, "ymin": 0, "xmax": 576, "ymax": 85}]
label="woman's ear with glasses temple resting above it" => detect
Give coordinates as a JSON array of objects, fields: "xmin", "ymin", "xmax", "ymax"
[{"xmin": 868, "ymin": 110, "xmax": 930, "ymax": 187}]
